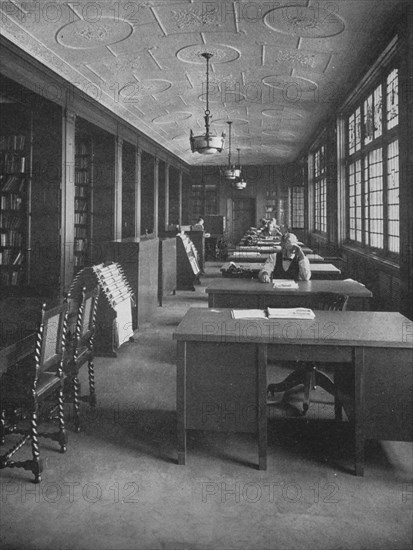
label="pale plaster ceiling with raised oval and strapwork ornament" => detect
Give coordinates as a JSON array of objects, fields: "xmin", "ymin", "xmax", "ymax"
[{"xmin": 0, "ymin": 0, "xmax": 403, "ymax": 165}]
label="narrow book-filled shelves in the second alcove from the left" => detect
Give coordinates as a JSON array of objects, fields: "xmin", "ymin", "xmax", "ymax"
[{"xmin": 73, "ymin": 135, "xmax": 93, "ymax": 275}]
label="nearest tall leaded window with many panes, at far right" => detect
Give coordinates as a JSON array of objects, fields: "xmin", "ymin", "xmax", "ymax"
[{"xmin": 346, "ymin": 68, "xmax": 399, "ymax": 254}]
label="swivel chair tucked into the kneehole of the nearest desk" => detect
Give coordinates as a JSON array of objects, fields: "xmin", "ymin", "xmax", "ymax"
[{"xmin": 267, "ymin": 292, "xmax": 348, "ymax": 419}]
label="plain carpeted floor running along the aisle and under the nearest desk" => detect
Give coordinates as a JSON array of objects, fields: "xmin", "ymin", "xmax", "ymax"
[{"xmin": 0, "ymin": 264, "xmax": 413, "ymax": 550}]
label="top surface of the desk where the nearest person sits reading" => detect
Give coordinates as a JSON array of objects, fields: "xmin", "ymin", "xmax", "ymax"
[{"xmin": 205, "ymin": 278, "xmax": 373, "ymax": 298}]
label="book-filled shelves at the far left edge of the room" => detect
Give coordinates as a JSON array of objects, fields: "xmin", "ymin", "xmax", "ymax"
[{"xmin": 0, "ymin": 133, "xmax": 30, "ymax": 287}]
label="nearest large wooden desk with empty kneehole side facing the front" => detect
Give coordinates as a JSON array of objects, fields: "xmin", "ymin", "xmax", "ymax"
[{"xmin": 173, "ymin": 308, "xmax": 413, "ymax": 475}]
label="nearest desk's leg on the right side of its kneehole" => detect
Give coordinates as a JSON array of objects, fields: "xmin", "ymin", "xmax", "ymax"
[{"xmin": 354, "ymin": 348, "xmax": 364, "ymax": 476}]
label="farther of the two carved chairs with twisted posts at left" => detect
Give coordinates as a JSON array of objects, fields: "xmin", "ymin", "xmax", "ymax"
[{"xmin": 67, "ymin": 287, "xmax": 99, "ymax": 432}]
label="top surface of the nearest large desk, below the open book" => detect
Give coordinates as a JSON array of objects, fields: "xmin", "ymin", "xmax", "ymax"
[{"xmin": 173, "ymin": 308, "xmax": 413, "ymax": 350}]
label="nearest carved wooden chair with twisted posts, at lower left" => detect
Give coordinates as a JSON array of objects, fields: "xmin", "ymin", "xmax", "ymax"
[{"xmin": 0, "ymin": 300, "xmax": 68, "ymax": 483}]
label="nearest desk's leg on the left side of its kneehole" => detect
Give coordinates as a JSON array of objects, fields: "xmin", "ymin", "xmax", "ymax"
[{"xmin": 257, "ymin": 344, "xmax": 267, "ymax": 470}]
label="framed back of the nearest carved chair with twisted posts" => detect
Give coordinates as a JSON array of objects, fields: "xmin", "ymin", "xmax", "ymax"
[{"xmin": 35, "ymin": 300, "xmax": 68, "ymax": 379}]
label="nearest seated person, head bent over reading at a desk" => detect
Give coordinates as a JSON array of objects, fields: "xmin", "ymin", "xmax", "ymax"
[{"xmin": 258, "ymin": 233, "xmax": 311, "ymax": 283}]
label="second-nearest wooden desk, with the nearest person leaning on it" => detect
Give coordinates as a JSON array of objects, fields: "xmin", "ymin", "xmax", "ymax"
[{"xmin": 205, "ymin": 278, "xmax": 373, "ymax": 310}]
